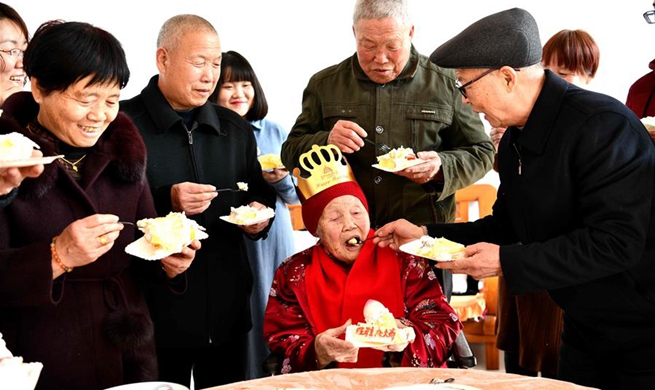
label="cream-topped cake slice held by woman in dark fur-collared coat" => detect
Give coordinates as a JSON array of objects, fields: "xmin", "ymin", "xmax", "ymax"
[{"xmin": 136, "ymin": 212, "xmax": 207, "ymax": 253}]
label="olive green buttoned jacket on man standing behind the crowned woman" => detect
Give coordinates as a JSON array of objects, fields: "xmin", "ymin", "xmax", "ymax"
[{"xmin": 282, "ymin": 46, "xmax": 494, "ymax": 227}]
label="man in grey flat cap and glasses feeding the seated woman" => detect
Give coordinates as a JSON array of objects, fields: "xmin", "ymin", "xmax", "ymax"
[{"xmin": 377, "ymin": 8, "xmax": 655, "ymax": 389}]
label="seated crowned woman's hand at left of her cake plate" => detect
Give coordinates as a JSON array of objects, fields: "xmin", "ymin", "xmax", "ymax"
[{"xmin": 314, "ymin": 320, "xmax": 359, "ymax": 368}]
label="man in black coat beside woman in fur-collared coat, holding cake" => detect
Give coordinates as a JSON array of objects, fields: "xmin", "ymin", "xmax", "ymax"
[{"xmin": 121, "ymin": 15, "xmax": 275, "ymax": 388}]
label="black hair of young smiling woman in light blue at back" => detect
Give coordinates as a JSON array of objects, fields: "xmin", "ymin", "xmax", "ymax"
[{"xmin": 210, "ymin": 51, "xmax": 268, "ymax": 121}]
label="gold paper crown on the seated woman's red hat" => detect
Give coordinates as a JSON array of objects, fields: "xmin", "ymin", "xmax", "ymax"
[{"xmin": 293, "ymin": 145, "xmax": 355, "ymax": 199}]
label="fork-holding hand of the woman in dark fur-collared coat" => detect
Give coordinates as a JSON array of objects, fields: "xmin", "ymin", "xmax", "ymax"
[{"xmin": 53, "ymin": 214, "xmax": 123, "ymax": 277}]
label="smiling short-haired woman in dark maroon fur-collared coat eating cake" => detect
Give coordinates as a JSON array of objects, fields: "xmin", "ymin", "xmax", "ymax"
[{"xmin": 0, "ymin": 21, "xmax": 200, "ymax": 390}]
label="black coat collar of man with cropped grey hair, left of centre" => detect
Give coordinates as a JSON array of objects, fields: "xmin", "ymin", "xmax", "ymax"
[{"xmin": 141, "ymin": 75, "xmax": 226, "ymax": 135}]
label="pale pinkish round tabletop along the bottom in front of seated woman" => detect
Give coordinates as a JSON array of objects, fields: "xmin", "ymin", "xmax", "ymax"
[{"xmin": 202, "ymin": 368, "xmax": 589, "ymax": 390}]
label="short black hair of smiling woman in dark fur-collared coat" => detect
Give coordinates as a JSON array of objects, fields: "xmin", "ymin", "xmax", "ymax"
[{"xmin": 23, "ymin": 20, "xmax": 130, "ymax": 95}]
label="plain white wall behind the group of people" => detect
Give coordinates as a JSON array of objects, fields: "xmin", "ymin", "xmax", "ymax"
[{"xmin": 16, "ymin": 0, "xmax": 655, "ymax": 187}]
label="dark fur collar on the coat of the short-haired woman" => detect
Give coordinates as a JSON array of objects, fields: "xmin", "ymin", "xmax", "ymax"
[{"xmin": 0, "ymin": 92, "xmax": 146, "ymax": 198}]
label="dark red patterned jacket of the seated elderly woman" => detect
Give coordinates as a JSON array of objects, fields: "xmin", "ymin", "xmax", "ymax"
[{"xmin": 264, "ymin": 243, "xmax": 462, "ymax": 373}]
